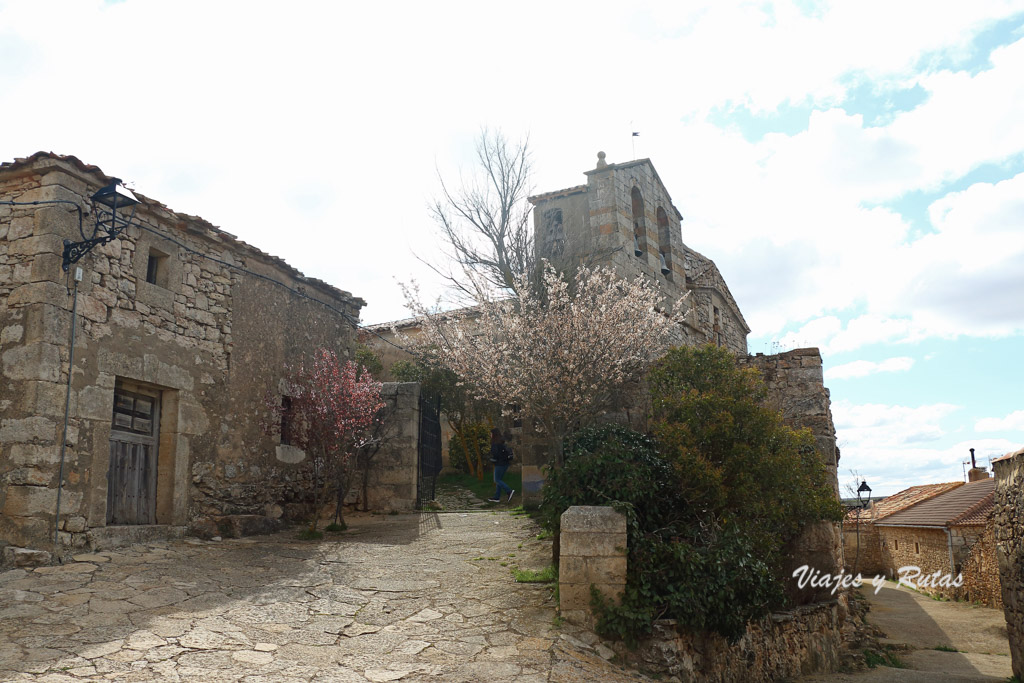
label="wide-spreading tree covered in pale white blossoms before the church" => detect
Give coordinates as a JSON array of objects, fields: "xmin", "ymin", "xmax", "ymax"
[{"xmin": 406, "ymin": 263, "xmax": 687, "ymax": 467}]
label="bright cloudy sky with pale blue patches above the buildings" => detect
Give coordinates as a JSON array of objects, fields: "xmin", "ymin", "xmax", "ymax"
[{"xmin": 0, "ymin": 0, "xmax": 1024, "ymax": 494}]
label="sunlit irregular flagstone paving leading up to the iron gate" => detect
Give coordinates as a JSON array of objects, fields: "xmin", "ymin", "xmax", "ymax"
[{"xmin": 0, "ymin": 512, "xmax": 647, "ymax": 683}]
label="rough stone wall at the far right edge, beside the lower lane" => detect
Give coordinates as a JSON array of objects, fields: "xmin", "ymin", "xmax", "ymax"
[{"xmin": 992, "ymin": 450, "xmax": 1024, "ymax": 680}]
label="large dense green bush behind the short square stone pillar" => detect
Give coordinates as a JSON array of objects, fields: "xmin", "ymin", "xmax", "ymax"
[{"xmin": 541, "ymin": 347, "xmax": 840, "ymax": 645}]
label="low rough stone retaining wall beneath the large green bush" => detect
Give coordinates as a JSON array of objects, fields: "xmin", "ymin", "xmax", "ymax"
[{"xmin": 612, "ymin": 600, "xmax": 842, "ymax": 683}]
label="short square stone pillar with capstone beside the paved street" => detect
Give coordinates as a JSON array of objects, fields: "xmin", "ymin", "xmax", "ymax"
[{"xmin": 558, "ymin": 506, "xmax": 627, "ymax": 628}]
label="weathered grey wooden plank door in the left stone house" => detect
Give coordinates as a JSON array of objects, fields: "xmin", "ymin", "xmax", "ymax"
[{"xmin": 106, "ymin": 386, "xmax": 160, "ymax": 524}]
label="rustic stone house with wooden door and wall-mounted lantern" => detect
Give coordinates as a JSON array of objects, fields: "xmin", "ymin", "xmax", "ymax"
[{"xmin": 0, "ymin": 153, "xmax": 416, "ymax": 555}]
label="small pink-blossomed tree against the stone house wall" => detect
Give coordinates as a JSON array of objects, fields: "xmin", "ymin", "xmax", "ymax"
[{"xmin": 265, "ymin": 348, "xmax": 385, "ymax": 536}]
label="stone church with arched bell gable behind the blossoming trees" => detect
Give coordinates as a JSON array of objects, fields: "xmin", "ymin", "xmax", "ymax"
[{"xmin": 367, "ymin": 153, "xmax": 842, "ymax": 524}]
